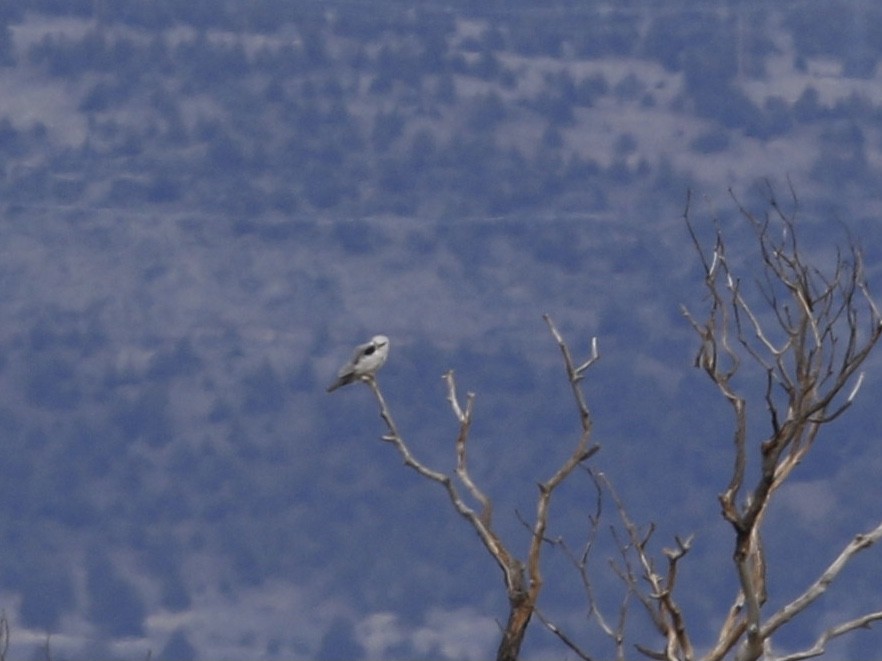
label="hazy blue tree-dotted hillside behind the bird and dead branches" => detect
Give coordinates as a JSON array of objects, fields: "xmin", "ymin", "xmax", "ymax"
[{"xmin": 0, "ymin": 0, "xmax": 882, "ymax": 660}]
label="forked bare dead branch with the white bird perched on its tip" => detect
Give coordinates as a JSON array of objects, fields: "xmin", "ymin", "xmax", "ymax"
[{"xmin": 365, "ymin": 315, "xmax": 600, "ymax": 661}]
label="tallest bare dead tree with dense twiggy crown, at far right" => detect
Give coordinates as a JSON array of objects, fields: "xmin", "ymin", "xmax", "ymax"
[{"xmin": 680, "ymin": 187, "xmax": 882, "ymax": 660}]
